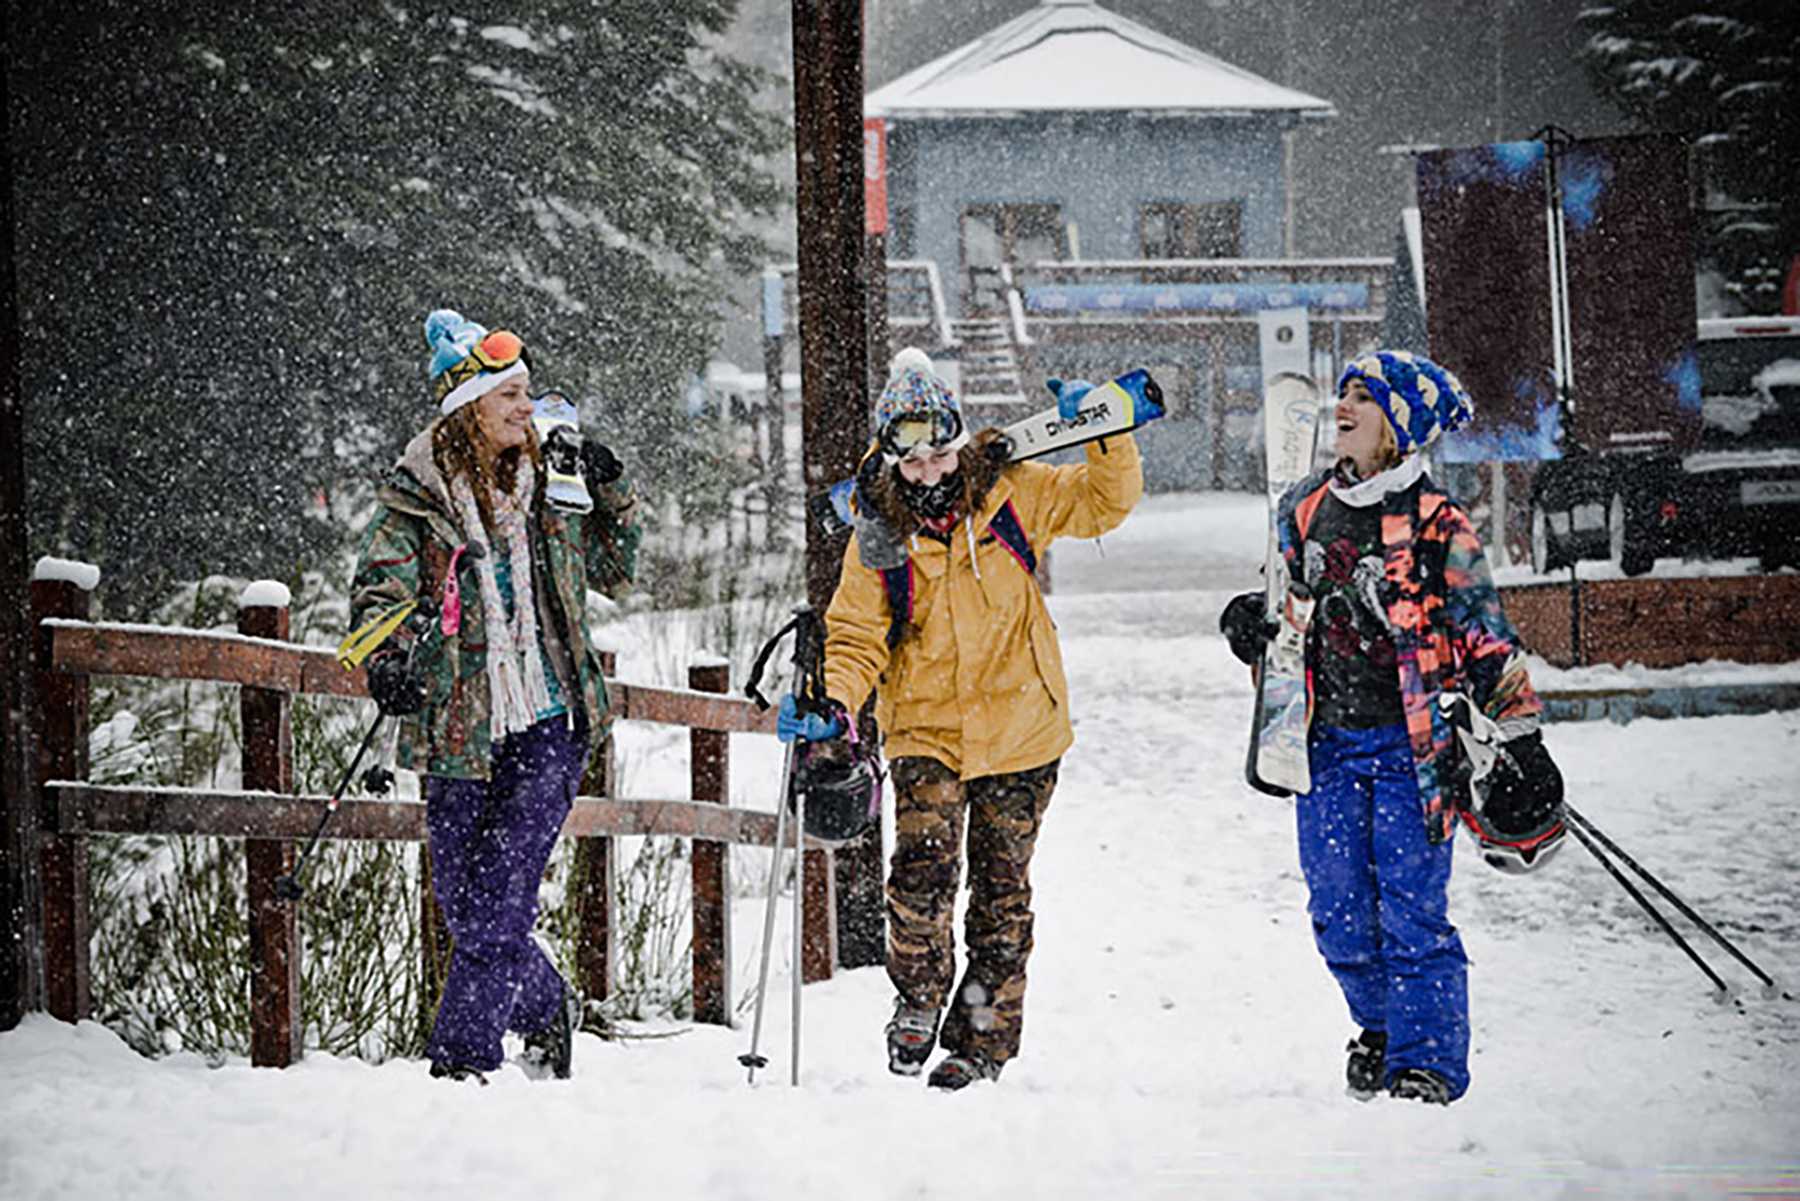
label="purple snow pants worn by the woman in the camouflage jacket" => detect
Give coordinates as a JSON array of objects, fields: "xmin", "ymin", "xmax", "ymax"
[{"xmin": 425, "ymin": 715, "xmax": 587, "ymax": 1071}]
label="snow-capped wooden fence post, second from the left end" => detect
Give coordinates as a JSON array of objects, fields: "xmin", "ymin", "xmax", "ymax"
[{"xmin": 238, "ymin": 580, "xmax": 306, "ymax": 1068}]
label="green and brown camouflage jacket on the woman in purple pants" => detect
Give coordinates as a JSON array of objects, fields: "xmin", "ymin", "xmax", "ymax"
[{"xmin": 349, "ymin": 430, "xmax": 643, "ymax": 780}]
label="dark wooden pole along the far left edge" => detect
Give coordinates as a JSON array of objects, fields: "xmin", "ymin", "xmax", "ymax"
[{"xmin": 0, "ymin": 16, "xmax": 43, "ymax": 1030}]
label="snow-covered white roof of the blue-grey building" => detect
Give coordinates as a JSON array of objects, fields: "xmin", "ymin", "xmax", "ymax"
[{"xmin": 864, "ymin": 0, "xmax": 1337, "ymax": 119}]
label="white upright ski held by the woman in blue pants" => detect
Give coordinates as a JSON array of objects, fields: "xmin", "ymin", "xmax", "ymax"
[{"xmin": 1244, "ymin": 373, "xmax": 1319, "ymax": 796}]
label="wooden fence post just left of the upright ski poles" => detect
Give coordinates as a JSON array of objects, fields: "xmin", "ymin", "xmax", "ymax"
[{"xmin": 688, "ymin": 663, "xmax": 731, "ymax": 1026}]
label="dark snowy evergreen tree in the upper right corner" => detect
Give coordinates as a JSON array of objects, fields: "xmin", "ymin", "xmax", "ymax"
[{"xmin": 1580, "ymin": 0, "xmax": 1800, "ymax": 313}]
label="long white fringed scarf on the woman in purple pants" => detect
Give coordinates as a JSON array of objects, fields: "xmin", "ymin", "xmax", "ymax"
[{"xmin": 450, "ymin": 456, "xmax": 551, "ymax": 744}]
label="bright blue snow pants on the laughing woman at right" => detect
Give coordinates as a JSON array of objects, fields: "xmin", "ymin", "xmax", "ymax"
[{"xmin": 1296, "ymin": 726, "xmax": 1469, "ymax": 1098}]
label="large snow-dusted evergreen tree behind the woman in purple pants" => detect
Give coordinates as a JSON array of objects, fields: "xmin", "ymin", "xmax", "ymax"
[{"xmin": 9, "ymin": 0, "xmax": 787, "ymax": 612}]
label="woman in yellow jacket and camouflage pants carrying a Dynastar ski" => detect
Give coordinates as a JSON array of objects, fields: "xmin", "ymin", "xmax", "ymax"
[{"xmin": 781, "ymin": 351, "xmax": 1143, "ymax": 1089}]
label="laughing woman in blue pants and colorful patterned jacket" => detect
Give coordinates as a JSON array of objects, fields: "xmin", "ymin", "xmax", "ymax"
[{"xmin": 1220, "ymin": 351, "xmax": 1562, "ymax": 1104}]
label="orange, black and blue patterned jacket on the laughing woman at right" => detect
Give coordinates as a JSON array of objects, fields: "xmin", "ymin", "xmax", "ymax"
[{"xmin": 1276, "ymin": 470, "xmax": 1543, "ymax": 843}]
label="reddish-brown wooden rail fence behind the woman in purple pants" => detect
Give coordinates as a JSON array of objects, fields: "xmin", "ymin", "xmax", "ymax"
[{"xmin": 31, "ymin": 573, "xmax": 837, "ymax": 1068}]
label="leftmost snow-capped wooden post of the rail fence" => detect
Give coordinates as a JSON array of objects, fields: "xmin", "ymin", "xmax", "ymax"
[{"xmin": 31, "ymin": 560, "xmax": 99, "ymax": 1021}]
